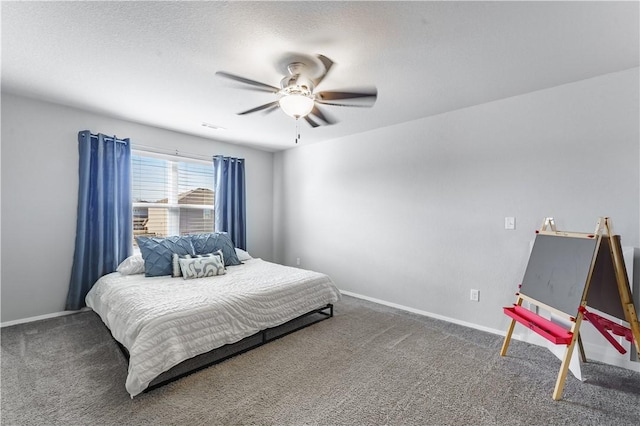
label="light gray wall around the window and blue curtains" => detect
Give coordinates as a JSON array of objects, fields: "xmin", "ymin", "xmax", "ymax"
[{"xmin": 1, "ymin": 93, "xmax": 273, "ymax": 322}]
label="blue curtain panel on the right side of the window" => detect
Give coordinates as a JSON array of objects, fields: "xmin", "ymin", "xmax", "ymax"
[{"xmin": 213, "ymin": 155, "xmax": 247, "ymax": 250}]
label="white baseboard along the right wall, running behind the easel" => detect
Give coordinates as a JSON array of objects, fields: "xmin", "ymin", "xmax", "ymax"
[{"xmin": 340, "ymin": 290, "xmax": 640, "ymax": 372}]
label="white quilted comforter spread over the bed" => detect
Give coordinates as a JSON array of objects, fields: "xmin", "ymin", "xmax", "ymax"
[{"xmin": 86, "ymin": 259, "xmax": 340, "ymax": 397}]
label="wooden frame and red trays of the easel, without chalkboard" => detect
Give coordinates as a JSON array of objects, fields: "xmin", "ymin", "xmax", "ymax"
[{"xmin": 500, "ymin": 217, "xmax": 640, "ymax": 401}]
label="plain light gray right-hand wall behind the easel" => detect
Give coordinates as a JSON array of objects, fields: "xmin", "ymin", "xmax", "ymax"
[{"xmin": 274, "ymin": 68, "xmax": 640, "ymax": 368}]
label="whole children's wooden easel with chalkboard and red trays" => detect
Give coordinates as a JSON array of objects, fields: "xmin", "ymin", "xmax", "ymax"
[{"xmin": 500, "ymin": 217, "xmax": 640, "ymax": 400}]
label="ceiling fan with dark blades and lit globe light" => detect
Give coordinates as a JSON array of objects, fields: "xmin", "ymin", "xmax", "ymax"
[{"xmin": 216, "ymin": 54, "xmax": 378, "ymax": 127}]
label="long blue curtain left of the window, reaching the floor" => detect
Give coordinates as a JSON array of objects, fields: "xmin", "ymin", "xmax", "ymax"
[{"xmin": 66, "ymin": 130, "xmax": 133, "ymax": 310}]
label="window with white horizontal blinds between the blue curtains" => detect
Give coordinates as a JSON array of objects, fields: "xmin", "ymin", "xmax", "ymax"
[{"xmin": 131, "ymin": 152, "xmax": 214, "ymax": 246}]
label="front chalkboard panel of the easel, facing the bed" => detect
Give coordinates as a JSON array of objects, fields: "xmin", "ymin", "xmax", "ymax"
[{"xmin": 520, "ymin": 234, "xmax": 600, "ymax": 316}]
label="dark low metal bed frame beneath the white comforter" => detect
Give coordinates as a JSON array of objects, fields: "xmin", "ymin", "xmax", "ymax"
[{"xmin": 114, "ymin": 303, "xmax": 333, "ymax": 392}]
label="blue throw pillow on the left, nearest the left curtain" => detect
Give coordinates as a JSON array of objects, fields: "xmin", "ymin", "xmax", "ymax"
[{"xmin": 136, "ymin": 235, "xmax": 194, "ymax": 277}]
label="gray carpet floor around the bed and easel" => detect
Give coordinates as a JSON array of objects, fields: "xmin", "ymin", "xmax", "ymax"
[{"xmin": 0, "ymin": 297, "xmax": 640, "ymax": 425}]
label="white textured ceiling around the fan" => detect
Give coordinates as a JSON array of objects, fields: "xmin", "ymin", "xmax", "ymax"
[{"xmin": 1, "ymin": 1, "xmax": 640, "ymax": 150}]
